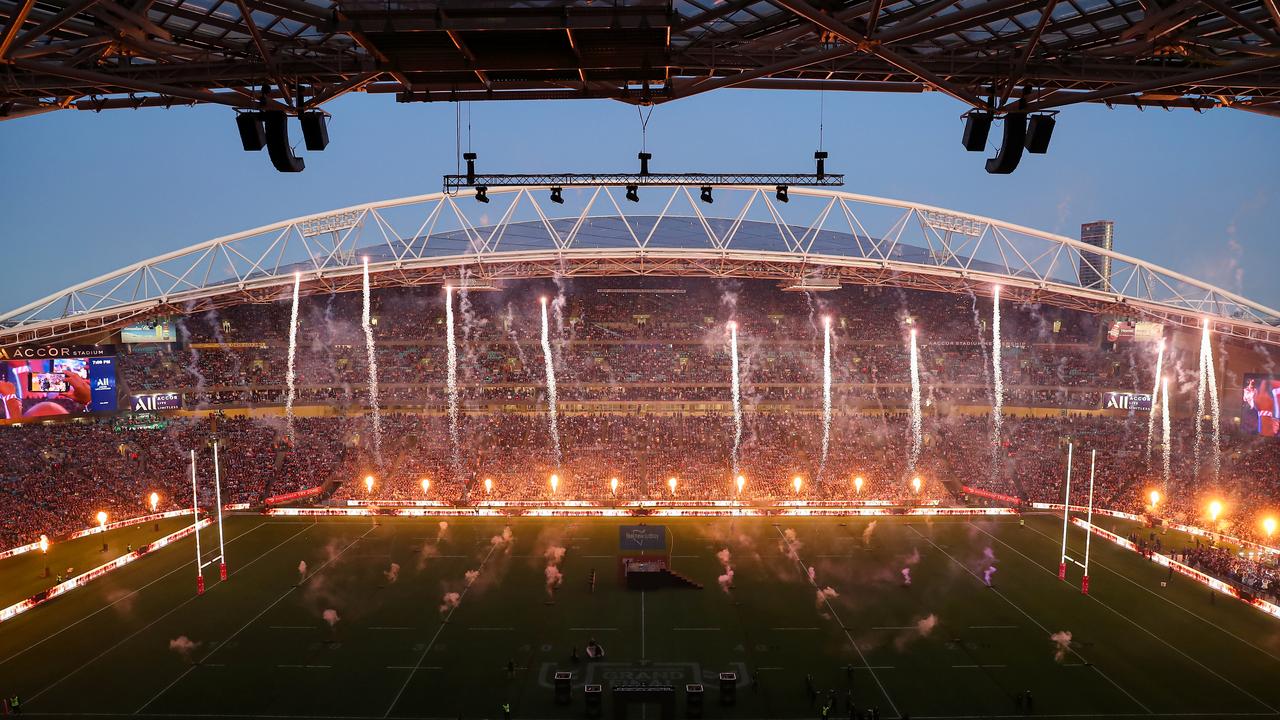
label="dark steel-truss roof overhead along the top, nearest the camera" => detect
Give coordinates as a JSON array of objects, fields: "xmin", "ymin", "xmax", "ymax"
[{"xmin": 0, "ymin": 0, "xmax": 1280, "ymax": 118}]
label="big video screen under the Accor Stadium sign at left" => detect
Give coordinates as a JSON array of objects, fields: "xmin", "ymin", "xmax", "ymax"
[{"xmin": 0, "ymin": 346, "xmax": 115, "ymax": 421}]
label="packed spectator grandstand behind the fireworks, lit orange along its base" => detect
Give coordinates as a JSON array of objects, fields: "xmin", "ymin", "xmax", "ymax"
[{"xmin": 0, "ymin": 278, "xmax": 1280, "ymax": 599}]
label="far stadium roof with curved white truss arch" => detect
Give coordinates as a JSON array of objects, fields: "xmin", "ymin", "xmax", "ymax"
[{"xmin": 0, "ymin": 186, "xmax": 1280, "ymax": 346}]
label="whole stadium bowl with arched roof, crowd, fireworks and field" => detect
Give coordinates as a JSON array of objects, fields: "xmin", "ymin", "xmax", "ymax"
[{"xmin": 0, "ymin": 178, "xmax": 1280, "ymax": 719}]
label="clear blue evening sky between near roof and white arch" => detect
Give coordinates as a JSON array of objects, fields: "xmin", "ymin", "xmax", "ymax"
[{"xmin": 0, "ymin": 90, "xmax": 1280, "ymax": 309}]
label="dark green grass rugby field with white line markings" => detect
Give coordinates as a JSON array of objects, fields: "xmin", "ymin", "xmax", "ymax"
[{"xmin": 0, "ymin": 516, "xmax": 1280, "ymax": 719}]
